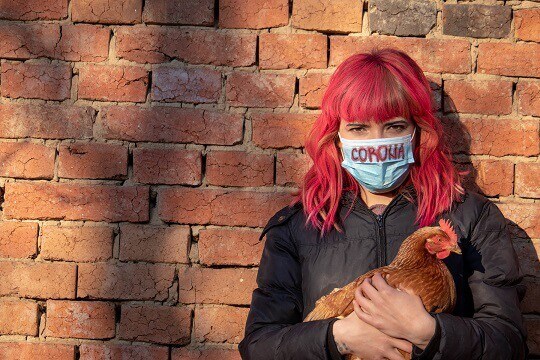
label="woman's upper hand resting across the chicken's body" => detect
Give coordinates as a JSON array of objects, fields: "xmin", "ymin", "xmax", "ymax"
[{"xmin": 353, "ymin": 272, "xmax": 436, "ymax": 349}]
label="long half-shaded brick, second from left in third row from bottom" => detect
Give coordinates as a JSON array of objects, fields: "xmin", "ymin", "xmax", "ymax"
[{"xmin": 77, "ymin": 263, "xmax": 174, "ymax": 301}]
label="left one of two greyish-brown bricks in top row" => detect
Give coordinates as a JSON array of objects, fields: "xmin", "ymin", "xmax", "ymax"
[{"xmin": 369, "ymin": 0, "xmax": 437, "ymax": 36}]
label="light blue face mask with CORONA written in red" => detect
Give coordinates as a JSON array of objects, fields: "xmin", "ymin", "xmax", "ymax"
[{"xmin": 338, "ymin": 128, "xmax": 416, "ymax": 193}]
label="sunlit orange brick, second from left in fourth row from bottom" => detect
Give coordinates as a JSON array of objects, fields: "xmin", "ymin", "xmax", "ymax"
[{"xmin": 40, "ymin": 224, "xmax": 114, "ymax": 262}]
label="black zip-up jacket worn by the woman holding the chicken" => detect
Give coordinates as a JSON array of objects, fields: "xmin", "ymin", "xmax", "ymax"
[{"xmin": 238, "ymin": 185, "xmax": 529, "ymax": 360}]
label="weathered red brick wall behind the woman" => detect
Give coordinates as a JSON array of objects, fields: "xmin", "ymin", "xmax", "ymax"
[{"xmin": 0, "ymin": 0, "xmax": 540, "ymax": 360}]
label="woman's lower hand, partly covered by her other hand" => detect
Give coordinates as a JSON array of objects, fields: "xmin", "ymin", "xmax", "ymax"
[{"xmin": 333, "ymin": 305, "xmax": 412, "ymax": 360}]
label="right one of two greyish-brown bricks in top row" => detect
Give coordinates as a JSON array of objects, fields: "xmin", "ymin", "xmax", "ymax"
[{"xmin": 443, "ymin": 4, "xmax": 512, "ymax": 39}]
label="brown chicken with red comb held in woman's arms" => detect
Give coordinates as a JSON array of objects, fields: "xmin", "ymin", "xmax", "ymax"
[{"xmin": 304, "ymin": 219, "xmax": 461, "ymax": 360}]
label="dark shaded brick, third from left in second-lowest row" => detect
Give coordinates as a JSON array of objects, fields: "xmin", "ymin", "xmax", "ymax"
[{"xmin": 118, "ymin": 304, "xmax": 192, "ymax": 345}]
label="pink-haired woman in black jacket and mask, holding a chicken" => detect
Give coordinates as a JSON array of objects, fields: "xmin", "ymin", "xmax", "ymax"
[{"xmin": 239, "ymin": 49, "xmax": 528, "ymax": 360}]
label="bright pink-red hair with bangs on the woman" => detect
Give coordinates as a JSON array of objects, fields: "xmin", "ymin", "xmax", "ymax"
[{"xmin": 291, "ymin": 48, "xmax": 466, "ymax": 235}]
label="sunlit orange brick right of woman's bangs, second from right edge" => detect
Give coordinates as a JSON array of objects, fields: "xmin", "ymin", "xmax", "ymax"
[{"xmin": 444, "ymin": 80, "xmax": 512, "ymax": 115}]
